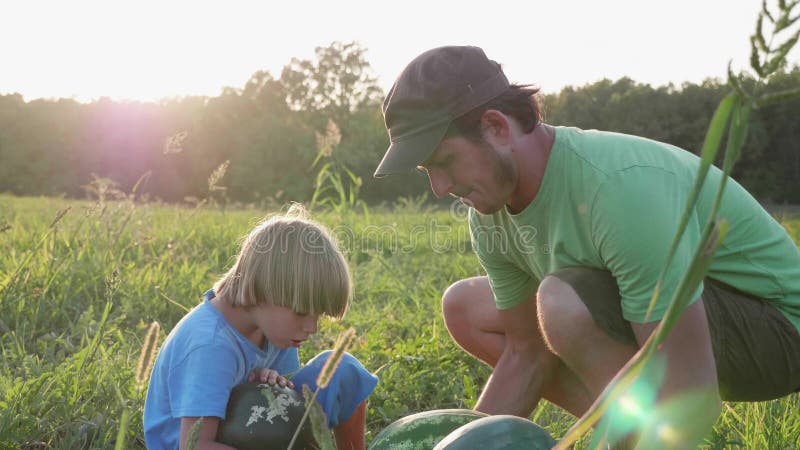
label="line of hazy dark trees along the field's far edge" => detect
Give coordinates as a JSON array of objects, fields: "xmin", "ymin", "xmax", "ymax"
[{"xmin": 0, "ymin": 42, "xmax": 800, "ymax": 204}]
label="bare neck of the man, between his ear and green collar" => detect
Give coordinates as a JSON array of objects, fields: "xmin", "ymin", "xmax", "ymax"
[{"xmin": 506, "ymin": 123, "xmax": 556, "ymax": 214}]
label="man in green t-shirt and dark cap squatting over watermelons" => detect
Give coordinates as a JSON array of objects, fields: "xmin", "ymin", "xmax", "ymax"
[{"xmin": 375, "ymin": 47, "xmax": 800, "ymax": 448}]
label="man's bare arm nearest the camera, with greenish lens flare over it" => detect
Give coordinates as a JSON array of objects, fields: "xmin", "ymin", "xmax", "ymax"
[{"xmin": 631, "ymin": 299, "xmax": 722, "ymax": 449}]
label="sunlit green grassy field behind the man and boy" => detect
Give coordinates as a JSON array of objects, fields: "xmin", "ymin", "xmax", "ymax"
[{"xmin": 0, "ymin": 195, "xmax": 800, "ymax": 449}]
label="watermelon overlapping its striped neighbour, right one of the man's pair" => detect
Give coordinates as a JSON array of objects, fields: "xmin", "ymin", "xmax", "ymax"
[{"xmin": 433, "ymin": 415, "xmax": 556, "ymax": 450}]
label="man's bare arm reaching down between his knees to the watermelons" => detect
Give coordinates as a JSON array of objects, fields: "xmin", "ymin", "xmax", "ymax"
[{"xmin": 475, "ymin": 291, "xmax": 557, "ymax": 417}]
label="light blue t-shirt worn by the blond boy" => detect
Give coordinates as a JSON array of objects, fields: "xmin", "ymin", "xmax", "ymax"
[{"xmin": 144, "ymin": 291, "xmax": 300, "ymax": 449}]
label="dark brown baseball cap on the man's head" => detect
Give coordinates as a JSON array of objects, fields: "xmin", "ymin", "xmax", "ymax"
[{"xmin": 374, "ymin": 46, "xmax": 509, "ymax": 178}]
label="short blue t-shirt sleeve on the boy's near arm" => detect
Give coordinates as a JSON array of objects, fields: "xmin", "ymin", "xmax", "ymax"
[{"xmin": 167, "ymin": 345, "xmax": 240, "ymax": 419}]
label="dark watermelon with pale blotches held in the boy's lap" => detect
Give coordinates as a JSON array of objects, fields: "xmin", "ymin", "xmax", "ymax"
[{"xmin": 216, "ymin": 382, "xmax": 319, "ymax": 450}]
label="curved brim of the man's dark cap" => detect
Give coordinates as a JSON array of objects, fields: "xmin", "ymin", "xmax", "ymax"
[{"xmin": 372, "ymin": 122, "xmax": 450, "ymax": 178}]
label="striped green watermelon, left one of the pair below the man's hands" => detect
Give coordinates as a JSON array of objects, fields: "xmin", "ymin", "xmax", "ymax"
[{"xmin": 367, "ymin": 409, "xmax": 488, "ymax": 450}]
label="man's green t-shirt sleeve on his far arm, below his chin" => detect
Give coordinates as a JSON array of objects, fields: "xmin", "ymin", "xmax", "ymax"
[{"xmin": 469, "ymin": 211, "xmax": 539, "ymax": 309}]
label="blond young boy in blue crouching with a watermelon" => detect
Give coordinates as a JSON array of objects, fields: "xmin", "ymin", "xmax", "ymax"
[{"xmin": 144, "ymin": 206, "xmax": 377, "ymax": 450}]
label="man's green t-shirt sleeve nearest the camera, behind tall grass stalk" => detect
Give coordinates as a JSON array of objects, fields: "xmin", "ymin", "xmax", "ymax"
[{"xmin": 591, "ymin": 166, "xmax": 703, "ymax": 323}]
